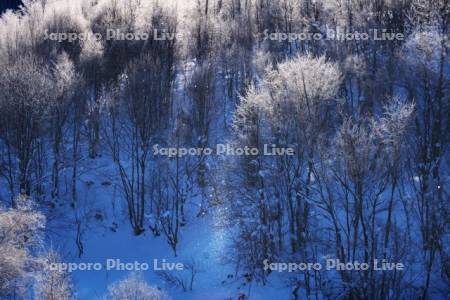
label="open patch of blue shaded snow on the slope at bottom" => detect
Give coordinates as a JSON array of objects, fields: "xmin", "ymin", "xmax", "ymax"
[{"xmin": 44, "ymin": 156, "xmax": 289, "ymax": 300}]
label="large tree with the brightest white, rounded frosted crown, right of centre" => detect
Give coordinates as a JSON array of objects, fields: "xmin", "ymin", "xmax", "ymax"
[{"xmin": 231, "ymin": 56, "xmax": 341, "ymax": 288}]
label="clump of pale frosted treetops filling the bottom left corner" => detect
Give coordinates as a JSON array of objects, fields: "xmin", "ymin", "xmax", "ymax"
[{"xmin": 0, "ymin": 195, "xmax": 73, "ymax": 300}]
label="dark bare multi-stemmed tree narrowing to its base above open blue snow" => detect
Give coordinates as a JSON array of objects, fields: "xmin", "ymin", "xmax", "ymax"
[{"xmin": 105, "ymin": 24, "xmax": 175, "ymax": 235}]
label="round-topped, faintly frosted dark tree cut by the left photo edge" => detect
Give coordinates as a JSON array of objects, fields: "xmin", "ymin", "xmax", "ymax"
[{"xmin": 0, "ymin": 55, "xmax": 55, "ymax": 202}]
